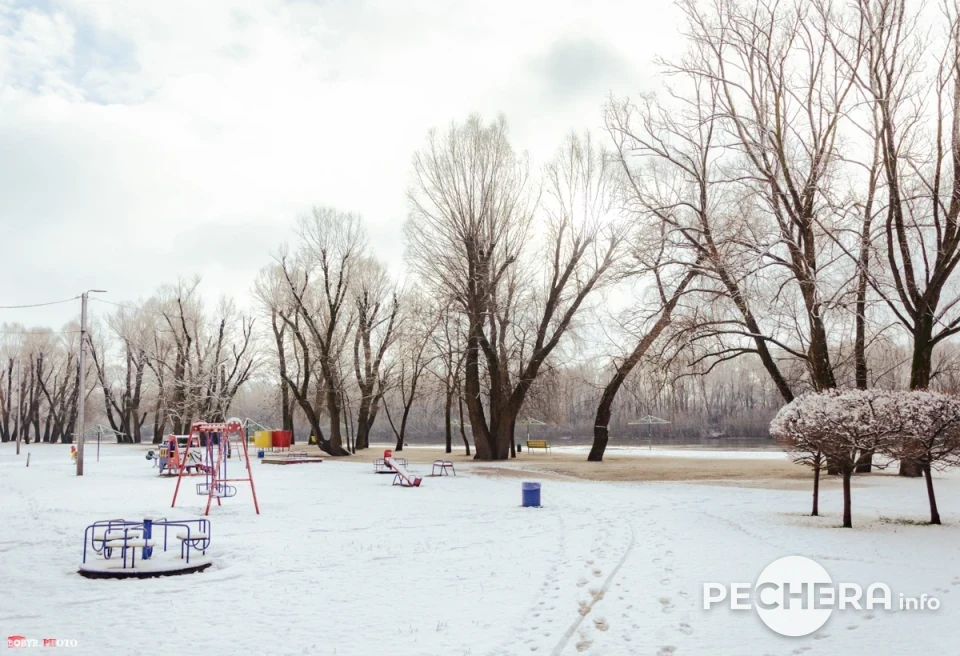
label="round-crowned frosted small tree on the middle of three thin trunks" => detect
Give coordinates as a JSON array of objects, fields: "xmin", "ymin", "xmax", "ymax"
[{"xmin": 770, "ymin": 389, "xmax": 902, "ymax": 528}]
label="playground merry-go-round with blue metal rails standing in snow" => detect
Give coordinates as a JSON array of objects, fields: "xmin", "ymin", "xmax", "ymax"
[{"xmin": 80, "ymin": 517, "xmax": 211, "ymax": 579}]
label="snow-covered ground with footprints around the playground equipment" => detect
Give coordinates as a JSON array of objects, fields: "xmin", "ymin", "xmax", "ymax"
[{"xmin": 0, "ymin": 444, "xmax": 960, "ymax": 656}]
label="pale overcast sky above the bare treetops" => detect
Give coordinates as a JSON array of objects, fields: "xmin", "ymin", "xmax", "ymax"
[{"xmin": 0, "ymin": 0, "xmax": 678, "ymax": 328}]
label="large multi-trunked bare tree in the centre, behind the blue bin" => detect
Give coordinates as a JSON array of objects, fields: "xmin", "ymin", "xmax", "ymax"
[{"xmin": 406, "ymin": 116, "xmax": 622, "ymax": 460}]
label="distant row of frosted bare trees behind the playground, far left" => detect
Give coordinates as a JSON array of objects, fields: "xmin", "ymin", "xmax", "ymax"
[{"xmin": 0, "ymin": 280, "xmax": 260, "ymax": 442}]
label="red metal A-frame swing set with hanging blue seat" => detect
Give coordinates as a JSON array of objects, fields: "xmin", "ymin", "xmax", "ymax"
[{"xmin": 170, "ymin": 419, "xmax": 260, "ymax": 515}]
